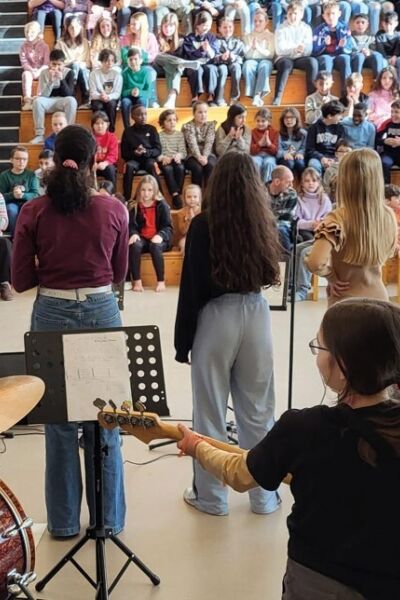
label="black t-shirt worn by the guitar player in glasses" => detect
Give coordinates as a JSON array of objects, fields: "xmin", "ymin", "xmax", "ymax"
[{"xmin": 247, "ymin": 402, "xmax": 400, "ymax": 600}]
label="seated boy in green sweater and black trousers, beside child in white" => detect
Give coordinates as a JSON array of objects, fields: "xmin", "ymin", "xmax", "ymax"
[{"xmin": 121, "ymin": 48, "xmax": 151, "ymax": 129}]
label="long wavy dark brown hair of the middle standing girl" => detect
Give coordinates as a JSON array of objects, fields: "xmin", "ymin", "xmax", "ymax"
[{"xmin": 204, "ymin": 152, "xmax": 281, "ymax": 293}]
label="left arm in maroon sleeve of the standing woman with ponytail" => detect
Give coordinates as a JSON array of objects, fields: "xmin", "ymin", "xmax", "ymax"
[{"xmin": 11, "ymin": 202, "xmax": 39, "ymax": 293}]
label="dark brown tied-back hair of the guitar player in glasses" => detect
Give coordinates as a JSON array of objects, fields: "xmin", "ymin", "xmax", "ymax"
[{"xmin": 321, "ymin": 298, "xmax": 400, "ymax": 464}]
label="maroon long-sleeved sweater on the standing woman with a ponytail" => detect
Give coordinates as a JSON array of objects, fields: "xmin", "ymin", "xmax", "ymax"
[{"xmin": 11, "ymin": 196, "xmax": 128, "ymax": 292}]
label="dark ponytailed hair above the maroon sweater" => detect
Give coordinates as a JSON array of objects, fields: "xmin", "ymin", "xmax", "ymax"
[{"xmin": 47, "ymin": 125, "xmax": 96, "ymax": 215}]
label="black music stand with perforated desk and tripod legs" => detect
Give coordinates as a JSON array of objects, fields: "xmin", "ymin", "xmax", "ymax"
[{"xmin": 25, "ymin": 326, "xmax": 169, "ymax": 600}]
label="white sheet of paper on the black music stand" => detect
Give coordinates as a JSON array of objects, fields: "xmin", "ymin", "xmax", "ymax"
[{"xmin": 62, "ymin": 331, "xmax": 132, "ymax": 421}]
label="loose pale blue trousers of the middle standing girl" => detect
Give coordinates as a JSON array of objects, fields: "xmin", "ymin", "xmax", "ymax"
[{"xmin": 191, "ymin": 294, "xmax": 280, "ymax": 514}]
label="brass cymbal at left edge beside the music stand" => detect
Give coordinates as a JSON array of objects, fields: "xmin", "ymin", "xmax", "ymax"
[{"xmin": 0, "ymin": 375, "xmax": 44, "ymax": 432}]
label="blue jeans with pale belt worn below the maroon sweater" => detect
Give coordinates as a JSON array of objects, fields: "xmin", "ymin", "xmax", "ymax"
[{"xmin": 31, "ymin": 294, "xmax": 126, "ymax": 537}]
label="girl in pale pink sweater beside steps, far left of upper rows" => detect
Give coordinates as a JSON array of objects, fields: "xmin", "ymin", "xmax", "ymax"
[{"xmin": 19, "ymin": 21, "xmax": 50, "ymax": 110}]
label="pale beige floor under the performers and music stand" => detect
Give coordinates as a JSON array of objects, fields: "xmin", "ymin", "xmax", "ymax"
[{"xmin": 0, "ymin": 288, "xmax": 340, "ymax": 600}]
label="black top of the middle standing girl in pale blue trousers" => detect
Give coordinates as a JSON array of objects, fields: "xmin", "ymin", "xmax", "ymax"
[{"xmin": 175, "ymin": 213, "xmax": 226, "ymax": 363}]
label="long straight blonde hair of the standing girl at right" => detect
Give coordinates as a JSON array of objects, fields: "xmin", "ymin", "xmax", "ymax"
[{"xmin": 336, "ymin": 148, "xmax": 397, "ymax": 266}]
